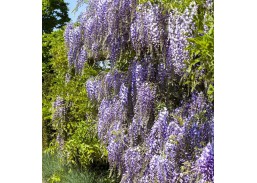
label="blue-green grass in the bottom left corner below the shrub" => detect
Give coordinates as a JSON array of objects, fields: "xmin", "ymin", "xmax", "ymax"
[{"xmin": 42, "ymin": 153, "xmax": 114, "ymax": 183}]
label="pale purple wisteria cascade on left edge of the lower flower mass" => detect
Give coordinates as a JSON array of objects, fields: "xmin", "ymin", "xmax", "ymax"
[{"xmin": 98, "ymin": 98, "xmax": 127, "ymax": 169}]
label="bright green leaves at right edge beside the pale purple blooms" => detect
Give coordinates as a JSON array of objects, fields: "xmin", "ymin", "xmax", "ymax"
[{"xmin": 182, "ymin": 1, "xmax": 214, "ymax": 102}]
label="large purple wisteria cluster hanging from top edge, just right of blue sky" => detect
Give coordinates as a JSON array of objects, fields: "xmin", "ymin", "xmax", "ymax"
[{"xmin": 72, "ymin": 0, "xmax": 136, "ymax": 62}]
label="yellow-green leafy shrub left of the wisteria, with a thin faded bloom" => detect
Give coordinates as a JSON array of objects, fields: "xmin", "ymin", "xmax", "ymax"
[{"xmin": 43, "ymin": 30, "xmax": 107, "ymax": 170}]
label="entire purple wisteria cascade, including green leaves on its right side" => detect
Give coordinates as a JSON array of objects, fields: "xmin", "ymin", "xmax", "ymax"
[{"xmin": 61, "ymin": 0, "xmax": 214, "ymax": 183}]
